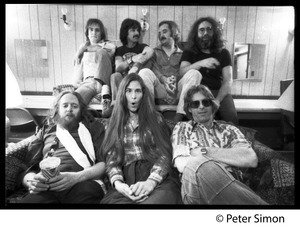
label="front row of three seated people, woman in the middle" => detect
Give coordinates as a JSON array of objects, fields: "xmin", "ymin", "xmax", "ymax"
[{"xmin": 21, "ymin": 73, "xmax": 267, "ymax": 205}]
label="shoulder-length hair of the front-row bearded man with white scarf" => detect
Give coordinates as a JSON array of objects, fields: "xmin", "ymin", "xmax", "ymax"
[{"xmin": 45, "ymin": 91, "xmax": 94, "ymax": 126}]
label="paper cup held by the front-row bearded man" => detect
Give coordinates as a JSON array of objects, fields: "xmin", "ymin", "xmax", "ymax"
[{"xmin": 40, "ymin": 157, "xmax": 60, "ymax": 179}]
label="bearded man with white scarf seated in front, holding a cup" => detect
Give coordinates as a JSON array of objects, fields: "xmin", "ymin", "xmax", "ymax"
[{"xmin": 20, "ymin": 91, "xmax": 106, "ymax": 204}]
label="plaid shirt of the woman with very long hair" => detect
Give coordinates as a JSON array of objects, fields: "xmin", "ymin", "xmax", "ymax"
[{"xmin": 108, "ymin": 121, "xmax": 168, "ymax": 184}]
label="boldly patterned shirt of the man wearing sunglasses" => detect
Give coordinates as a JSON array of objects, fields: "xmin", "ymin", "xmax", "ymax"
[{"xmin": 172, "ymin": 120, "xmax": 251, "ymax": 170}]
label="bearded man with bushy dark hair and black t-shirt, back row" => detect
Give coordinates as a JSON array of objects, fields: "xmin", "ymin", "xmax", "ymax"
[{"xmin": 176, "ymin": 17, "xmax": 238, "ymax": 125}]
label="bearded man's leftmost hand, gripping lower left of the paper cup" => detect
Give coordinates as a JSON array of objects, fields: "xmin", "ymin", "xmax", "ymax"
[{"xmin": 24, "ymin": 173, "xmax": 50, "ymax": 194}]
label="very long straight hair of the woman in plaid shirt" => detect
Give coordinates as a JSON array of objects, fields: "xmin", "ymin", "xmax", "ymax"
[{"xmin": 102, "ymin": 73, "xmax": 172, "ymax": 170}]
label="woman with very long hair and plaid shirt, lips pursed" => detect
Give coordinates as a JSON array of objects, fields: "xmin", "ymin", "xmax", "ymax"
[{"xmin": 101, "ymin": 73, "xmax": 182, "ymax": 204}]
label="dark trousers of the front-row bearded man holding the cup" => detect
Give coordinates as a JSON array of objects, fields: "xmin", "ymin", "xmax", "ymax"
[{"xmin": 19, "ymin": 181, "xmax": 104, "ymax": 204}]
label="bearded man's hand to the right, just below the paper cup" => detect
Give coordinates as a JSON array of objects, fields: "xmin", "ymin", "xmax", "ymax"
[{"xmin": 47, "ymin": 172, "xmax": 79, "ymax": 192}]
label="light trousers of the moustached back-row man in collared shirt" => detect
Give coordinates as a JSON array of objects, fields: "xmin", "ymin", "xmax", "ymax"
[{"xmin": 139, "ymin": 68, "xmax": 202, "ymax": 114}]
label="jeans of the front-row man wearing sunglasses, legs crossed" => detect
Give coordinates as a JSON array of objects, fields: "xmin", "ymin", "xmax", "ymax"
[{"xmin": 181, "ymin": 155, "xmax": 267, "ymax": 205}]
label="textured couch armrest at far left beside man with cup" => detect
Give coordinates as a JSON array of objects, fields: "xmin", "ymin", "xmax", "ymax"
[{"xmin": 5, "ymin": 135, "xmax": 34, "ymax": 195}]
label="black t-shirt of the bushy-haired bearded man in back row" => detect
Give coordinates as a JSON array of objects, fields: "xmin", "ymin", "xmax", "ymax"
[{"xmin": 180, "ymin": 49, "xmax": 232, "ymax": 90}]
